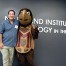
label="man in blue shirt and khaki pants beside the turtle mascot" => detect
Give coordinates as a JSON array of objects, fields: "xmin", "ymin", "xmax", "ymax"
[{"xmin": 0, "ymin": 10, "xmax": 19, "ymax": 66}]
